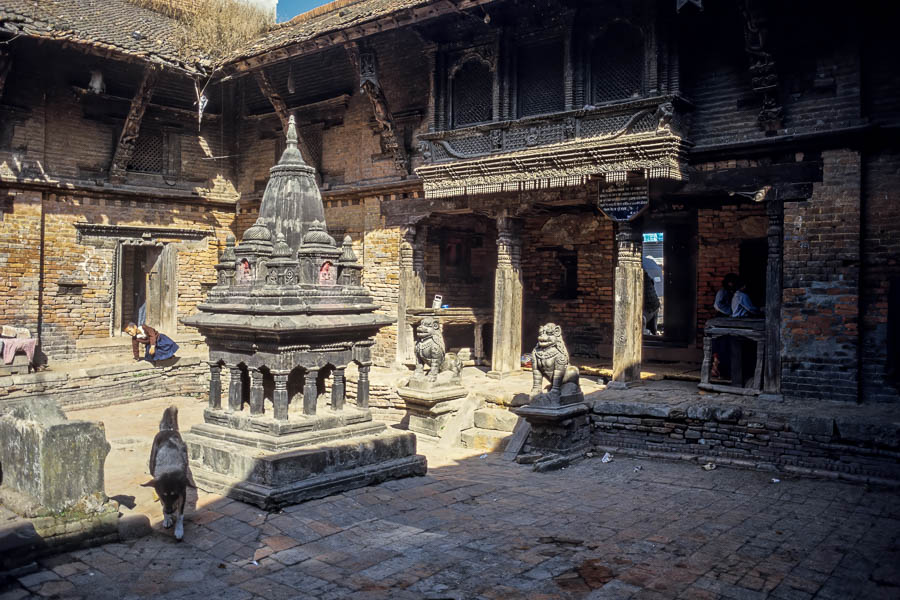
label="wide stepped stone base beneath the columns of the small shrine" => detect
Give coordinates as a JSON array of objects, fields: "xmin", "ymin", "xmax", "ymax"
[{"xmin": 183, "ymin": 403, "xmax": 427, "ymax": 510}]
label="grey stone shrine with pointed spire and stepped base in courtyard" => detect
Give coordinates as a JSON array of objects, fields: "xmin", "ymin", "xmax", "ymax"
[{"xmin": 184, "ymin": 117, "xmax": 426, "ymax": 508}]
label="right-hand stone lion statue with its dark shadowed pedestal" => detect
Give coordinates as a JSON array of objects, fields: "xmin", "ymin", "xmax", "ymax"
[{"xmin": 513, "ymin": 323, "xmax": 591, "ymax": 471}]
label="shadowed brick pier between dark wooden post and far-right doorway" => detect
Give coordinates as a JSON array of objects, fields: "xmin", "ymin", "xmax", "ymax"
[{"xmin": 782, "ymin": 150, "xmax": 861, "ymax": 401}]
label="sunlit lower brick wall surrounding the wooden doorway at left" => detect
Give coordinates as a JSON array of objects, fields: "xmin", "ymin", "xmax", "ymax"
[{"xmin": 0, "ymin": 192, "xmax": 234, "ymax": 359}]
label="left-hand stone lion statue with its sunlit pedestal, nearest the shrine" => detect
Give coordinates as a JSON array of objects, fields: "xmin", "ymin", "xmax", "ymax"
[{"xmin": 397, "ymin": 317, "xmax": 468, "ymax": 439}]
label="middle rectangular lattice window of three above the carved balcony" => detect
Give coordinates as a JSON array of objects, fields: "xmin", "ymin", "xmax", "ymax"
[{"xmin": 517, "ymin": 39, "xmax": 566, "ymax": 117}]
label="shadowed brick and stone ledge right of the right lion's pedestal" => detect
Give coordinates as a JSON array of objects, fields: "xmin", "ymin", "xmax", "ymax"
[{"xmin": 588, "ymin": 382, "xmax": 900, "ymax": 484}]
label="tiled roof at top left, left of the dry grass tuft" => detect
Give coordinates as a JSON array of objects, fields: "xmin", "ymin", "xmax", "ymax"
[{"xmin": 0, "ymin": 0, "xmax": 194, "ymax": 70}]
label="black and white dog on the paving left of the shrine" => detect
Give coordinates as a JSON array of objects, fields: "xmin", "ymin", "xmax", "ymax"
[{"xmin": 141, "ymin": 406, "xmax": 197, "ymax": 540}]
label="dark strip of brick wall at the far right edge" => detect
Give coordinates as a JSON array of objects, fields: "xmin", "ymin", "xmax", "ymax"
[{"xmin": 860, "ymin": 151, "xmax": 900, "ymax": 402}]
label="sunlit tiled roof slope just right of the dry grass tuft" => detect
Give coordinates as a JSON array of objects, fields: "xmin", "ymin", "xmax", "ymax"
[{"xmin": 232, "ymin": 0, "xmax": 434, "ymax": 60}]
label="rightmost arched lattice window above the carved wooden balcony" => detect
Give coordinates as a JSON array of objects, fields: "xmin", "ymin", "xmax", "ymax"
[{"xmin": 591, "ymin": 23, "xmax": 644, "ymax": 104}]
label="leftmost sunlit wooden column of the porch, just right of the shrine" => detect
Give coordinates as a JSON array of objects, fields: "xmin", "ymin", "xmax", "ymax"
[{"xmin": 397, "ymin": 225, "xmax": 428, "ymax": 365}]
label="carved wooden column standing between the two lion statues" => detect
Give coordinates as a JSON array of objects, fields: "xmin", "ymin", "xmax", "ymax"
[{"xmin": 488, "ymin": 216, "xmax": 522, "ymax": 378}]
